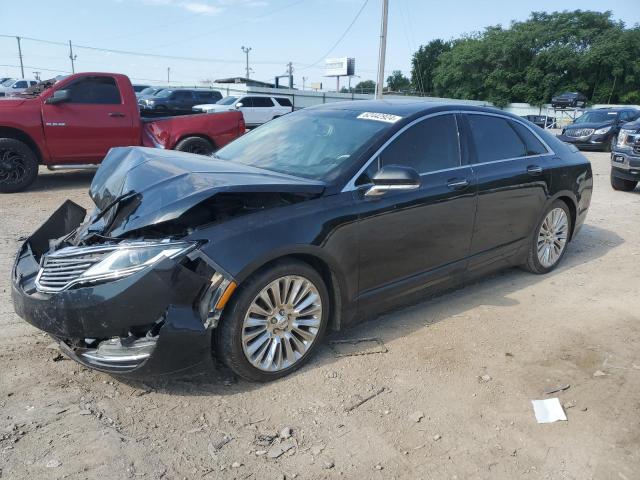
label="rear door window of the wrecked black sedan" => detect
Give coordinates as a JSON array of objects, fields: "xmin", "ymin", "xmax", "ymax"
[{"xmin": 467, "ymin": 115, "xmax": 526, "ymax": 163}]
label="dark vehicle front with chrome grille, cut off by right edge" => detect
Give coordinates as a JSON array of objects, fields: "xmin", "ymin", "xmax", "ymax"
[{"xmin": 611, "ymin": 120, "xmax": 640, "ymax": 192}]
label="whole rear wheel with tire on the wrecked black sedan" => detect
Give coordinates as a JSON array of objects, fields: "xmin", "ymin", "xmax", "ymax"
[{"xmin": 523, "ymin": 200, "xmax": 573, "ymax": 274}]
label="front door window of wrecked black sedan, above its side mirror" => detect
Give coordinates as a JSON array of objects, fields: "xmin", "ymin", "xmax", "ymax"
[{"xmin": 380, "ymin": 115, "xmax": 460, "ymax": 174}]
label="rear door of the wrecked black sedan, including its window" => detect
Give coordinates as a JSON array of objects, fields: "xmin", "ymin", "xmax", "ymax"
[{"xmin": 465, "ymin": 112, "xmax": 553, "ymax": 274}]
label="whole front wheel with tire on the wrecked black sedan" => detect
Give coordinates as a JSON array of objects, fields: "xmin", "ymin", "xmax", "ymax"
[{"xmin": 214, "ymin": 260, "xmax": 330, "ymax": 382}]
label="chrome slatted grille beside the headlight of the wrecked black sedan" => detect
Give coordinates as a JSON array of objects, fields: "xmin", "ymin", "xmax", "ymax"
[{"xmin": 36, "ymin": 247, "xmax": 111, "ymax": 292}]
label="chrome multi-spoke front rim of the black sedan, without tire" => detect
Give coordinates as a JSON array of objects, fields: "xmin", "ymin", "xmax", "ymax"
[{"xmin": 242, "ymin": 275, "xmax": 322, "ymax": 372}]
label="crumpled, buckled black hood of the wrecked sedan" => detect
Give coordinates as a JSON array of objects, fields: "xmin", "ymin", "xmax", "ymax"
[{"xmin": 89, "ymin": 147, "xmax": 325, "ymax": 237}]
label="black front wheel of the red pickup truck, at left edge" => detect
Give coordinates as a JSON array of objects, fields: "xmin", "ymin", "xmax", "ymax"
[{"xmin": 0, "ymin": 138, "xmax": 38, "ymax": 193}]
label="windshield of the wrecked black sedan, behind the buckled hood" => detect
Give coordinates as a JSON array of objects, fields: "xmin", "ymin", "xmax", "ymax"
[{"xmin": 215, "ymin": 110, "xmax": 391, "ymax": 181}]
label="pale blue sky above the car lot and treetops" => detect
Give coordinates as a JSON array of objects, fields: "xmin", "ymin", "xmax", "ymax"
[{"xmin": 0, "ymin": 0, "xmax": 640, "ymax": 89}]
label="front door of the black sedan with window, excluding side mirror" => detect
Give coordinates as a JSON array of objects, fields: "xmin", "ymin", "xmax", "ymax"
[{"xmin": 356, "ymin": 114, "xmax": 476, "ymax": 300}]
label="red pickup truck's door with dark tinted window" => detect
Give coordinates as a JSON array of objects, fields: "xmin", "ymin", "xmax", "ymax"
[{"xmin": 42, "ymin": 75, "xmax": 139, "ymax": 163}]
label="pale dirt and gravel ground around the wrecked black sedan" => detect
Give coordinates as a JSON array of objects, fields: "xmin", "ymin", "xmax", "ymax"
[{"xmin": 0, "ymin": 153, "xmax": 640, "ymax": 480}]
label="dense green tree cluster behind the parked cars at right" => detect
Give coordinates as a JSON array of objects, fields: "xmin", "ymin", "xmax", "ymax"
[{"xmin": 412, "ymin": 10, "xmax": 640, "ymax": 106}]
